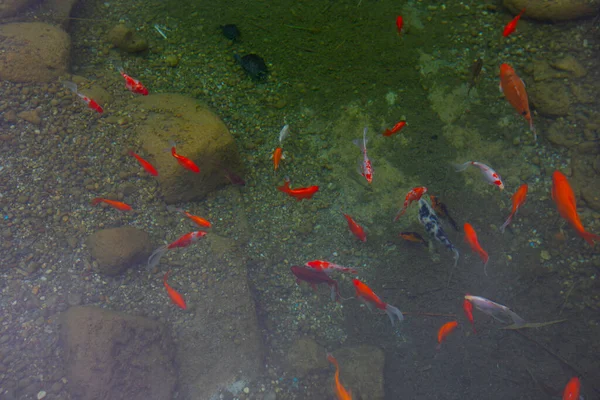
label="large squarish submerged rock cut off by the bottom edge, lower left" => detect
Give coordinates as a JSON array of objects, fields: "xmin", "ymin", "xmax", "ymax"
[{"xmin": 60, "ymin": 307, "xmax": 177, "ymax": 400}]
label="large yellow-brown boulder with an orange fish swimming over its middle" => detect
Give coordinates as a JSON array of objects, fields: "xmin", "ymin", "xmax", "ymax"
[{"xmin": 135, "ymin": 94, "xmax": 242, "ymax": 204}]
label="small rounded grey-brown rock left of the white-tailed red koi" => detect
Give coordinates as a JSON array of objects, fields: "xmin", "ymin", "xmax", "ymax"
[{"xmin": 87, "ymin": 226, "xmax": 152, "ymax": 275}]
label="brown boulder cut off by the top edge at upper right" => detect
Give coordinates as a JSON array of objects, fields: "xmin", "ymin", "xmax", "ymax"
[{"xmin": 504, "ymin": 0, "xmax": 600, "ymax": 21}]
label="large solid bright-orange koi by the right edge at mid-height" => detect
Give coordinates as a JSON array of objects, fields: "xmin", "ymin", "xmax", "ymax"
[{"xmin": 552, "ymin": 171, "xmax": 600, "ymax": 246}]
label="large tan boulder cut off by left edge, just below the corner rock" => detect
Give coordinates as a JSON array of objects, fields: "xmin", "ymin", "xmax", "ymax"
[{"xmin": 0, "ymin": 22, "xmax": 71, "ymax": 82}]
